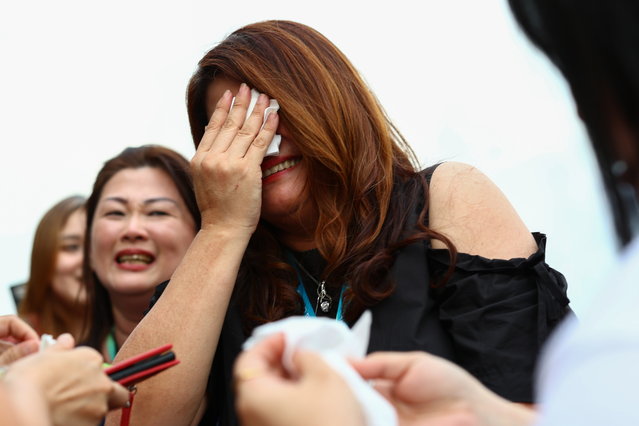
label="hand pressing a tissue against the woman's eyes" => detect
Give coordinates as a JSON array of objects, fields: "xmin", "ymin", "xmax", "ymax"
[{"xmin": 191, "ymin": 84, "xmax": 278, "ymax": 234}]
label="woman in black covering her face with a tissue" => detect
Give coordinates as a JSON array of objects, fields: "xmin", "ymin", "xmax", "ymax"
[{"xmin": 110, "ymin": 21, "xmax": 568, "ymax": 424}]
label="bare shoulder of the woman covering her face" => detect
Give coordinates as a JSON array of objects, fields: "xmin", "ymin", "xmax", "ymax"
[{"xmin": 429, "ymin": 162, "xmax": 537, "ymax": 259}]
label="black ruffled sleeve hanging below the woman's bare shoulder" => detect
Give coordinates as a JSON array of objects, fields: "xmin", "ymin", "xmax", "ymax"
[{"xmin": 428, "ymin": 233, "xmax": 570, "ymax": 402}]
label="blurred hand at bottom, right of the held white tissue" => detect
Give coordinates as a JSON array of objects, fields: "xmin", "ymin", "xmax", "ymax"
[{"xmin": 351, "ymin": 352, "xmax": 534, "ymax": 426}]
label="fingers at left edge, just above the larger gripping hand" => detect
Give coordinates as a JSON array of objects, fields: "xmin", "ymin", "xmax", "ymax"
[{"xmin": 0, "ymin": 315, "xmax": 40, "ymax": 365}]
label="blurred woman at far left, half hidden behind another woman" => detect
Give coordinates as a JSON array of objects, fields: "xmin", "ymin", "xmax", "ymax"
[{"xmin": 18, "ymin": 196, "xmax": 87, "ymax": 336}]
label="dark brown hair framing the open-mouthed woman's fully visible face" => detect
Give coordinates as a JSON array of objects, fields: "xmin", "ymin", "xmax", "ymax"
[{"xmin": 82, "ymin": 145, "xmax": 200, "ymax": 350}]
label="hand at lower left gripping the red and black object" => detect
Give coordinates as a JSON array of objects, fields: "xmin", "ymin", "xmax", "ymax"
[{"xmin": 3, "ymin": 334, "xmax": 129, "ymax": 425}]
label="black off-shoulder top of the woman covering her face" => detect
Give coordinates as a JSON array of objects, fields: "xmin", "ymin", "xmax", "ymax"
[{"xmin": 152, "ymin": 168, "xmax": 570, "ymax": 425}]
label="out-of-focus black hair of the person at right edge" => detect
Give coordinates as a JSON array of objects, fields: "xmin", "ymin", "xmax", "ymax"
[{"xmin": 509, "ymin": 0, "xmax": 639, "ymax": 245}]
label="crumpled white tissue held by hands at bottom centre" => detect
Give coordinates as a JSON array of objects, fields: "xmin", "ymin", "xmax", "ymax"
[{"xmin": 243, "ymin": 311, "xmax": 398, "ymax": 426}]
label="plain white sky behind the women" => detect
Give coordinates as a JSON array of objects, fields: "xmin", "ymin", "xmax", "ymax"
[{"xmin": 0, "ymin": 0, "xmax": 615, "ymax": 313}]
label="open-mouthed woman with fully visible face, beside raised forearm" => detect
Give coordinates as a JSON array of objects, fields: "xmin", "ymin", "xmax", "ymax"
[{"xmin": 83, "ymin": 145, "xmax": 200, "ymax": 362}]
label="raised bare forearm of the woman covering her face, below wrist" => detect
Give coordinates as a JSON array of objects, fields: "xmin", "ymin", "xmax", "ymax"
[{"xmin": 107, "ymin": 228, "xmax": 250, "ymax": 425}]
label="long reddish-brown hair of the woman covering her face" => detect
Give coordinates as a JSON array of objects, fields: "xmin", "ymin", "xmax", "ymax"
[{"xmin": 187, "ymin": 21, "xmax": 454, "ymax": 329}]
